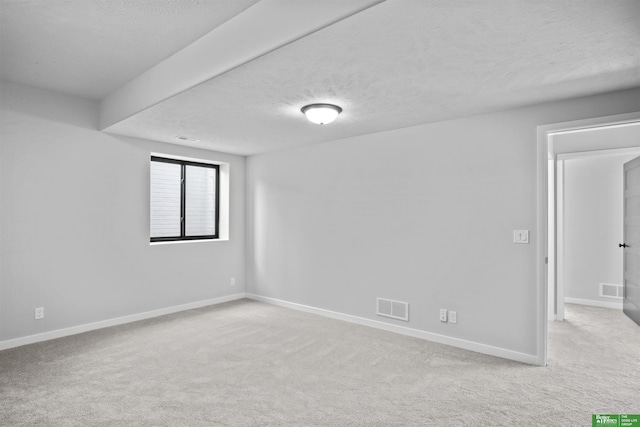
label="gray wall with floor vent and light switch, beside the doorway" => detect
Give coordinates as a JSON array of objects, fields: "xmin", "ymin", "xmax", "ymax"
[{"xmin": 247, "ymin": 90, "xmax": 640, "ymax": 354}]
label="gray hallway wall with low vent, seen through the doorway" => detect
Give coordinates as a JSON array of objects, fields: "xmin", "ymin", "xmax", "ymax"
[{"xmin": 564, "ymin": 153, "xmax": 640, "ymax": 304}]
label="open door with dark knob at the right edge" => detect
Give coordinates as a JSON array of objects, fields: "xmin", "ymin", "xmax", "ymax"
[{"xmin": 619, "ymin": 157, "xmax": 640, "ymax": 325}]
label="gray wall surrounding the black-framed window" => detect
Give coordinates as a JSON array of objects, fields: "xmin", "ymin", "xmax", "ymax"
[{"xmin": 0, "ymin": 82, "xmax": 245, "ymax": 341}]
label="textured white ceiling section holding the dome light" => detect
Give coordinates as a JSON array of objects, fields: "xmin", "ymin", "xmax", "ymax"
[{"xmin": 109, "ymin": 0, "xmax": 640, "ymax": 154}]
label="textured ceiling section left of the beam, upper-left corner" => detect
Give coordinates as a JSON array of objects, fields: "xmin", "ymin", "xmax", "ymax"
[{"xmin": 0, "ymin": 0, "xmax": 258, "ymax": 99}]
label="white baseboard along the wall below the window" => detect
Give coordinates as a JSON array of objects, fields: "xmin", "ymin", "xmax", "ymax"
[{"xmin": 0, "ymin": 292, "xmax": 245, "ymax": 350}]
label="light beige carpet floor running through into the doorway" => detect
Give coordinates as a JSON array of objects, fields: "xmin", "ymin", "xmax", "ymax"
[{"xmin": 0, "ymin": 300, "xmax": 640, "ymax": 426}]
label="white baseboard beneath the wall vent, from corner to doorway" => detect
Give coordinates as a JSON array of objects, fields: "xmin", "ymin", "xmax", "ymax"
[{"xmin": 245, "ymin": 293, "xmax": 539, "ymax": 365}]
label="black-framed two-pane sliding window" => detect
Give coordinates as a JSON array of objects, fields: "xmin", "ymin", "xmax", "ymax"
[{"xmin": 150, "ymin": 156, "xmax": 220, "ymax": 242}]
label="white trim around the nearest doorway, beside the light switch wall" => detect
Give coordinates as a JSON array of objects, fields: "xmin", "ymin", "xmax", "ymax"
[{"xmin": 536, "ymin": 111, "xmax": 640, "ymax": 366}]
